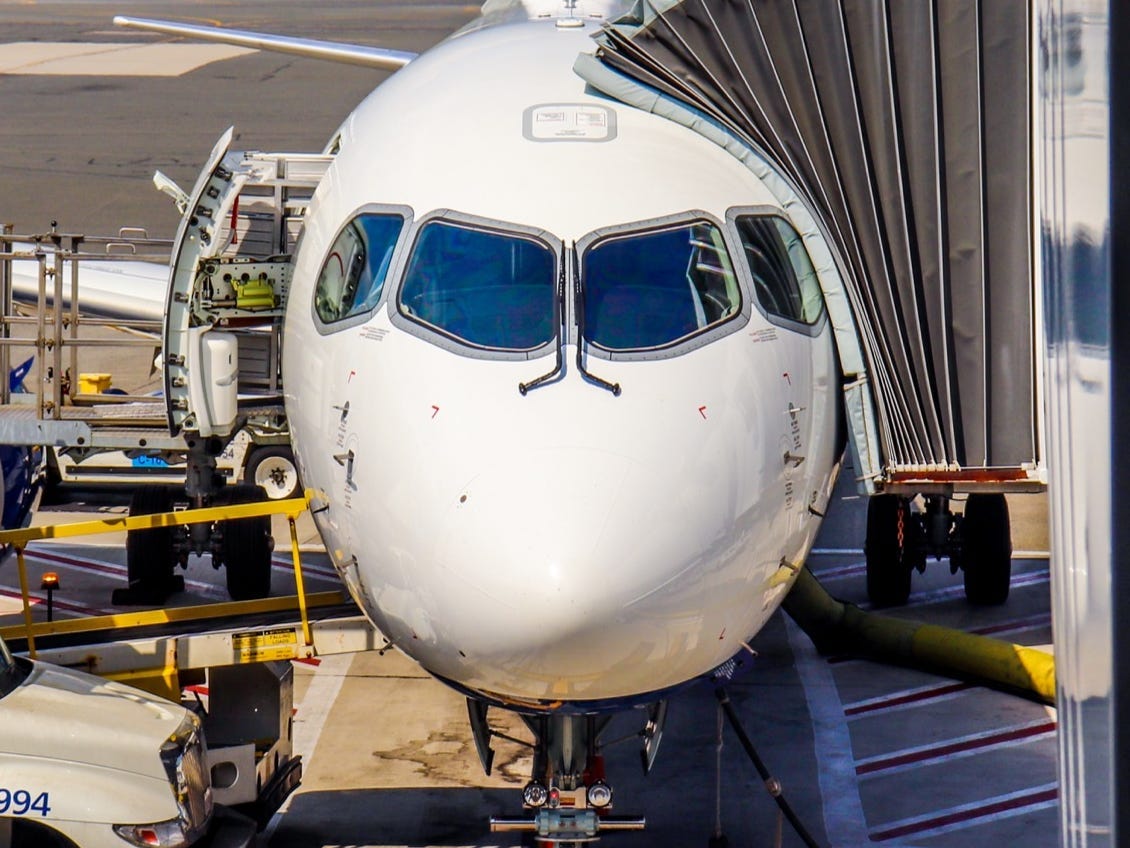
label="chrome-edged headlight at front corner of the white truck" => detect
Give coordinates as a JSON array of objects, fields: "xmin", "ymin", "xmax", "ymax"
[{"xmin": 114, "ymin": 712, "xmax": 212, "ymax": 848}]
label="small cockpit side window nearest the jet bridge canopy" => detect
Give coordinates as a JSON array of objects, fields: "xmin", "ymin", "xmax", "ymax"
[{"xmin": 737, "ymin": 215, "xmax": 824, "ymax": 325}]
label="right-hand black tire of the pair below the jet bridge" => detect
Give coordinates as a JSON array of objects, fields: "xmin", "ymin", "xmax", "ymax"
[{"xmin": 962, "ymin": 494, "xmax": 1012, "ymax": 606}]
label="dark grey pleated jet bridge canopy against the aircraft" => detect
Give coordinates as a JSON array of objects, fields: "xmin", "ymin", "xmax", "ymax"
[{"xmin": 577, "ymin": 0, "xmax": 1038, "ymax": 476}]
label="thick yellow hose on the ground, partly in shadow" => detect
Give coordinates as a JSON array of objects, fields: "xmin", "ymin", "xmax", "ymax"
[{"xmin": 783, "ymin": 569, "xmax": 1055, "ymax": 704}]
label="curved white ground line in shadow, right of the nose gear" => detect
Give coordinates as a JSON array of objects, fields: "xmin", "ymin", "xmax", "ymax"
[{"xmin": 784, "ymin": 616, "xmax": 868, "ymax": 846}]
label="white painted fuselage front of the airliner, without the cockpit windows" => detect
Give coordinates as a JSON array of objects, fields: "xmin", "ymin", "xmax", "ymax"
[{"xmin": 277, "ymin": 11, "xmax": 836, "ymax": 706}]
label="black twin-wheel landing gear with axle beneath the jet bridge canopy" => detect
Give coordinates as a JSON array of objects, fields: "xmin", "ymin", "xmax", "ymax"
[{"xmin": 864, "ymin": 493, "xmax": 1012, "ymax": 607}]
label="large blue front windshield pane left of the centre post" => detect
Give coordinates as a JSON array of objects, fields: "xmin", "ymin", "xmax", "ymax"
[{"xmin": 400, "ymin": 220, "xmax": 557, "ymax": 351}]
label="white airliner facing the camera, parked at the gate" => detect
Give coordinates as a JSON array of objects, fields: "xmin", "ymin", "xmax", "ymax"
[{"xmin": 28, "ymin": 0, "xmax": 844, "ymax": 842}]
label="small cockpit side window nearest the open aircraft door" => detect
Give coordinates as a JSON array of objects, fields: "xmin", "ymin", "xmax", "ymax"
[{"xmin": 314, "ymin": 214, "xmax": 405, "ymax": 323}]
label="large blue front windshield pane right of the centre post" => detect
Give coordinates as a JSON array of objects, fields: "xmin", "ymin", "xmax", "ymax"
[{"xmin": 581, "ymin": 220, "xmax": 741, "ymax": 351}]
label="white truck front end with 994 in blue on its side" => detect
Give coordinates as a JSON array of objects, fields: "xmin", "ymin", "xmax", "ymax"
[{"xmin": 0, "ymin": 640, "xmax": 257, "ymax": 848}]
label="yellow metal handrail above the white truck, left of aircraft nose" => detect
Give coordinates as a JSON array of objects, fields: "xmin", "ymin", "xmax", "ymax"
[{"xmin": 0, "ymin": 491, "xmax": 327, "ymax": 659}]
